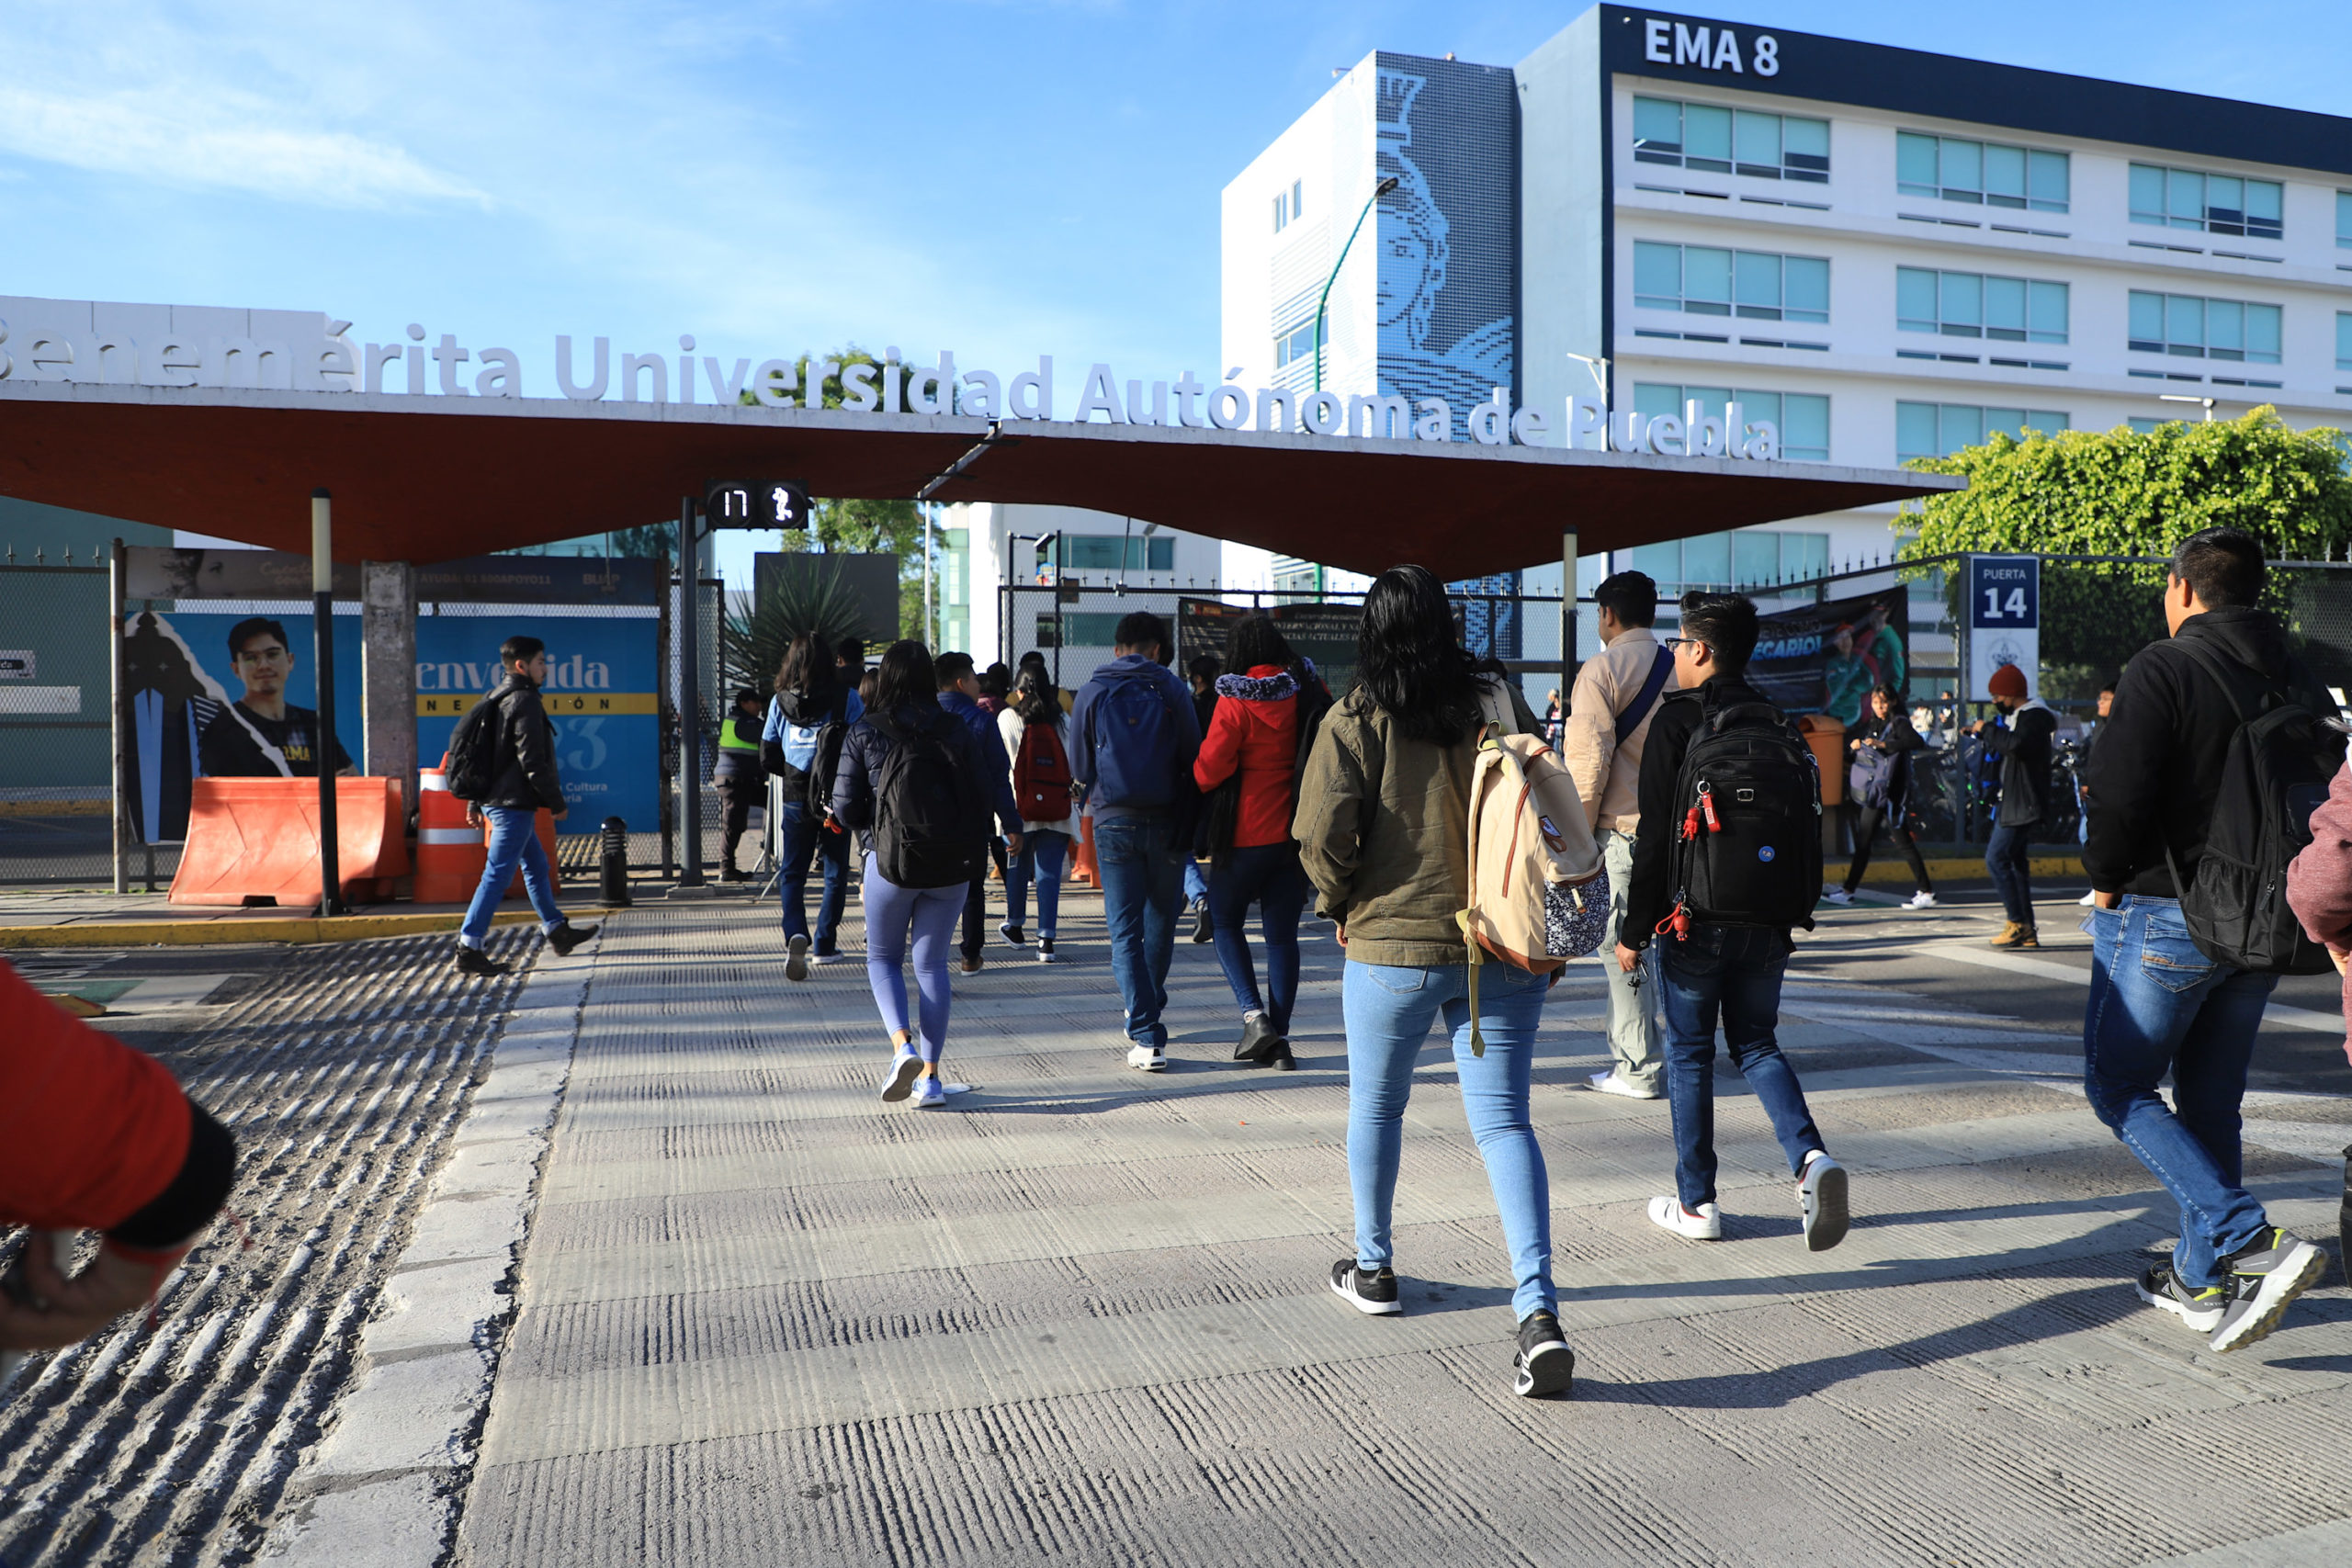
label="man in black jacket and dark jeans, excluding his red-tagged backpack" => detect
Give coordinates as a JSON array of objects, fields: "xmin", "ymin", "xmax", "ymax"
[{"xmin": 1616, "ymin": 592, "xmax": 1847, "ymax": 1253}]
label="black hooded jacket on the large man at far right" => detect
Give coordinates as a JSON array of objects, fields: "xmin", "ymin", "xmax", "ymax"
[{"xmin": 2082, "ymin": 606, "xmax": 2335, "ymax": 898}]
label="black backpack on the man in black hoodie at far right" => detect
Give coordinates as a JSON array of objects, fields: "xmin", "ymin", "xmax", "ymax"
[{"xmin": 2164, "ymin": 637, "xmax": 2345, "ymax": 976}]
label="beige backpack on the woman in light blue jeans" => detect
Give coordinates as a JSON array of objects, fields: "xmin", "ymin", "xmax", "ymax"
[{"xmin": 1453, "ymin": 682, "xmax": 1609, "ymax": 1055}]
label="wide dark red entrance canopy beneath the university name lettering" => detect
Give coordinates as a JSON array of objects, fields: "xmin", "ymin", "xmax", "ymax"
[{"xmin": 0, "ymin": 378, "xmax": 1964, "ymax": 581}]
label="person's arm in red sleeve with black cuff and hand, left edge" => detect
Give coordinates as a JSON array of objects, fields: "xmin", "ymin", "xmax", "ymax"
[{"xmin": 0, "ymin": 959, "xmax": 238, "ymax": 1352}]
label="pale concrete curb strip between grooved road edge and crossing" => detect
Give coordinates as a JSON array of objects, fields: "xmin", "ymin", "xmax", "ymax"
[{"xmin": 259, "ymin": 938, "xmax": 588, "ymax": 1568}]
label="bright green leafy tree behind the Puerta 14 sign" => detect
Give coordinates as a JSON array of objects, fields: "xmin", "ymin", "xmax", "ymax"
[{"xmin": 1898, "ymin": 407, "xmax": 2352, "ymax": 696}]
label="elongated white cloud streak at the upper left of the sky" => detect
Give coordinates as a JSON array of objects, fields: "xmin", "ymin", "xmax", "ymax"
[{"xmin": 0, "ymin": 85, "xmax": 487, "ymax": 207}]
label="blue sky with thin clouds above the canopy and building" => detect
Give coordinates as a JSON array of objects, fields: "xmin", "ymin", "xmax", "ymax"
[{"xmin": 0, "ymin": 0, "xmax": 2352, "ymax": 576}]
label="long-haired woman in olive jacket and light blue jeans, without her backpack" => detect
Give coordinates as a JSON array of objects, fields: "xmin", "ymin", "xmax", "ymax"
[{"xmin": 1296, "ymin": 567, "xmax": 1576, "ymax": 1394}]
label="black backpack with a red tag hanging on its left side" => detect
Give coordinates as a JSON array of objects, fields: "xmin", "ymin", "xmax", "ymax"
[{"xmin": 1675, "ymin": 698, "xmax": 1820, "ymax": 931}]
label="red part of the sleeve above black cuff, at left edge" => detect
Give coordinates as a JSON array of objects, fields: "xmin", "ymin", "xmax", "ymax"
[{"xmin": 0, "ymin": 962, "xmax": 188, "ymax": 1229}]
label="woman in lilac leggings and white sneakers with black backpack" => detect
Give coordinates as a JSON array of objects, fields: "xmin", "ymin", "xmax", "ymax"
[{"xmin": 832, "ymin": 642, "xmax": 1023, "ymax": 1110}]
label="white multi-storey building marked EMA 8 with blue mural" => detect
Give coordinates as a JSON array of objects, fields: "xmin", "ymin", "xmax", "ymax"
[{"xmin": 1223, "ymin": 5, "xmax": 2352, "ymax": 682}]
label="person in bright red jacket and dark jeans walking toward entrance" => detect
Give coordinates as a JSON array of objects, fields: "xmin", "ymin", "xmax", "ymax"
[{"xmin": 1193, "ymin": 614, "xmax": 1331, "ymax": 1069}]
